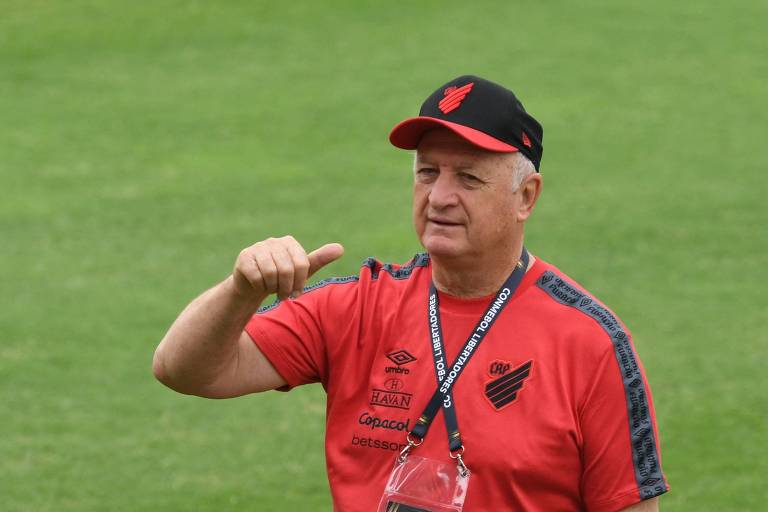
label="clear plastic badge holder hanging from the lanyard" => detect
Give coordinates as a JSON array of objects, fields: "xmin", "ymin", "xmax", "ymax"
[{"xmin": 378, "ymin": 455, "xmax": 470, "ymax": 512}]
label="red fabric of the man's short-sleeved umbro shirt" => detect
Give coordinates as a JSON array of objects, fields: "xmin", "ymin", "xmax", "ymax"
[{"xmin": 246, "ymin": 260, "xmax": 666, "ymax": 512}]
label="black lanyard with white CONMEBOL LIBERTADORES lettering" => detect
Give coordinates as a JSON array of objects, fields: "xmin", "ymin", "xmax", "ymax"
[{"xmin": 410, "ymin": 247, "xmax": 529, "ymax": 453}]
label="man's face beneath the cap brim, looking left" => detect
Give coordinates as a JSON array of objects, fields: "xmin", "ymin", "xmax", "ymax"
[{"xmin": 413, "ymin": 129, "xmax": 522, "ymax": 261}]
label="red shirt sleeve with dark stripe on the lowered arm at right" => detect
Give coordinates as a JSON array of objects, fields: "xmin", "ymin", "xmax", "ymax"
[{"xmin": 580, "ymin": 330, "xmax": 669, "ymax": 512}]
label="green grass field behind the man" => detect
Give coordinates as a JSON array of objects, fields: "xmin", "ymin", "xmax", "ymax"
[{"xmin": 0, "ymin": 0, "xmax": 768, "ymax": 511}]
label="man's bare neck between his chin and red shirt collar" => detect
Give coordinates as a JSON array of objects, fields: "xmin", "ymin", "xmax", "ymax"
[{"xmin": 431, "ymin": 243, "xmax": 536, "ymax": 299}]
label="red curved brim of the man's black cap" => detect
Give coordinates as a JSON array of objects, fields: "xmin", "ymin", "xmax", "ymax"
[{"xmin": 389, "ymin": 116, "xmax": 518, "ymax": 153}]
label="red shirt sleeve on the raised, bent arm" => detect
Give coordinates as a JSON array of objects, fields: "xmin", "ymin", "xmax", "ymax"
[{"xmin": 245, "ymin": 278, "xmax": 358, "ymax": 391}]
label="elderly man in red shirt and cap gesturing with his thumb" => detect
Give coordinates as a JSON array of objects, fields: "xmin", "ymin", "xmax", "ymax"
[{"xmin": 154, "ymin": 76, "xmax": 668, "ymax": 511}]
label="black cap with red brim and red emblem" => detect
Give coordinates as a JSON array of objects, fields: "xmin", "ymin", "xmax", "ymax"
[{"xmin": 389, "ymin": 75, "xmax": 544, "ymax": 171}]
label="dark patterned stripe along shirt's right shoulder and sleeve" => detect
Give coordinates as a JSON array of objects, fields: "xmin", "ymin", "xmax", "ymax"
[{"xmin": 536, "ymin": 271, "xmax": 667, "ymax": 499}]
